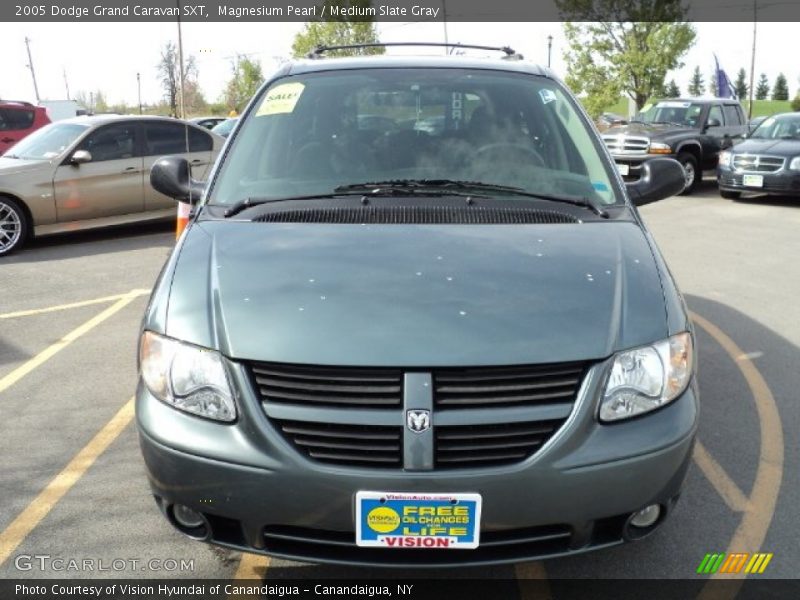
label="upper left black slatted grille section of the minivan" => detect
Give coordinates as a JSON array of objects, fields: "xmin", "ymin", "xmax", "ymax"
[{"xmin": 250, "ymin": 363, "xmax": 403, "ymax": 408}]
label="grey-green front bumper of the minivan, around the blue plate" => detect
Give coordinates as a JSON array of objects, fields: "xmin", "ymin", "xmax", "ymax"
[{"xmin": 136, "ymin": 364, "xmax": 698, "ymax": 566}]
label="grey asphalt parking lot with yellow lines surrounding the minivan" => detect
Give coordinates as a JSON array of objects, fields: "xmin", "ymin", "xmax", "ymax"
[{"xmin": 0, "ymin": 181, "xmax": 800, "ymax": 597}]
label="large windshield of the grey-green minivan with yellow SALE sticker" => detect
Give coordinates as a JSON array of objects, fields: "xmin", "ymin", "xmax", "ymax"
[{"xmin": 209, "ymin": 69, "xmax": 617, "ymax": 205}]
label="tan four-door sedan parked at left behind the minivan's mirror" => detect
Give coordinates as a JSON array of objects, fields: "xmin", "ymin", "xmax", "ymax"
[{"xmin": 0, "ymin": 115, "xmax": 223, "ymax": 255}]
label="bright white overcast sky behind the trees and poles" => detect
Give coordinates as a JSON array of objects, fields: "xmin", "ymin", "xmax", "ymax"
[{"xmin": 0, "ymin": 22, "xmax": 800, "ymax": 105}]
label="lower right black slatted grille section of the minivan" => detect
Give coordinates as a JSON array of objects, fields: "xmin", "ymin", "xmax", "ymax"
[{"xmin": 434, "ymin": 419, "xmax": 564, "ymax": 469}]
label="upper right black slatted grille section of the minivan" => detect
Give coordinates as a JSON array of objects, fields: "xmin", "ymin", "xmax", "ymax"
[{"xmin": 433, "ymin": 363, "xmax": 586, "ymax": 408}]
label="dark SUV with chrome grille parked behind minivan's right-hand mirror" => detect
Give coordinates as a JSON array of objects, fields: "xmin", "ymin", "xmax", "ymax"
[{"xmin": 603, "ymin": 98, "xmax": 747, "ymax": 194}]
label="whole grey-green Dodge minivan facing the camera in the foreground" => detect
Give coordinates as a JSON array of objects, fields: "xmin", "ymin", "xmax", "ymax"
[{"xmin": 136, "ymin": 44, "xmax": 698, "ymax": 566}]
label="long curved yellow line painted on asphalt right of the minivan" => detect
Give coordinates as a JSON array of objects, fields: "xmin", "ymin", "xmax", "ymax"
[{"xmin": 691, "ymin": 313, "xmax": 783, "ymax": 600}]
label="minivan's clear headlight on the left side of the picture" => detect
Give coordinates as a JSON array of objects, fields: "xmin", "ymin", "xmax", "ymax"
[{"xmin": 139, "ymin": 331, "xmax": 236, "ymax": 421}]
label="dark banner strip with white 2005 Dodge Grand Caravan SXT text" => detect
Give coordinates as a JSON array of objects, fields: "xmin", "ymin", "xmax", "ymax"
[{"xmin": 6, "ymin": 0, "xmax": 800, "ymax": 22}]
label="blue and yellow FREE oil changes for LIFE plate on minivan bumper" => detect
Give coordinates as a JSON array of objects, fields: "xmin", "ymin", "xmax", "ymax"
[{"xmin": 356, "ymin": 492, "xmax": 481, "ymax": 549}]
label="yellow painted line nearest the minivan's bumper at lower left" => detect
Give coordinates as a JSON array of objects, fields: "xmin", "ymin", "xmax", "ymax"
[{"xmin": 0, "ymin": 398, "xmax": 133, "ymax": 565}]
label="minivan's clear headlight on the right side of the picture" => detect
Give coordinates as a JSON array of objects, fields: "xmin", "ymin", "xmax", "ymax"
[{"xmin": 600, "ymin": 332, "xmax": 694, "ymax": 421}]
